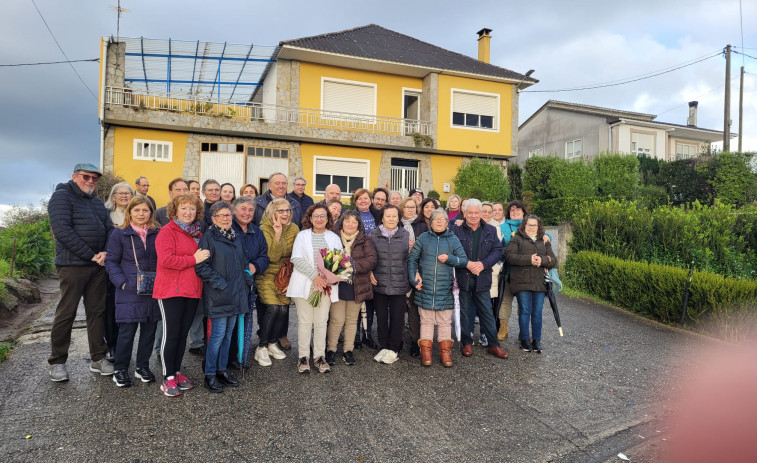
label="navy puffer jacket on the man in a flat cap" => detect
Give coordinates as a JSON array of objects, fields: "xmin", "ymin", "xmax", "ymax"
[{"xmin": 47, "ymin": 180, "xmax": 113, "ymax": 267}]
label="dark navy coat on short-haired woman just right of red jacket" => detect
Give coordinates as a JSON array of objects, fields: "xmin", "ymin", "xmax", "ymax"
[{"xmin": 195, "ymin": 227, "xmax": 253, "ymax": 318}]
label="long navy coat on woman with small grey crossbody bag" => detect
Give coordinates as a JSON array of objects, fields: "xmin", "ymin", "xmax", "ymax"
[{"xmin": 105, "ymin": 226, "xmax": 160, "ymax": 323}]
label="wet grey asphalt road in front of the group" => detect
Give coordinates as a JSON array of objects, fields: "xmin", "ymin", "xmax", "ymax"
[{"xmin": 0, "ymin": 284, "xmax": 718, "ymax": 462}]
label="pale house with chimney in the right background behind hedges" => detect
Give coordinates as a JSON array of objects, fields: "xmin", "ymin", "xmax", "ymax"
[{"xmin": 518, "ymin": 100, "xmax": 723, "ymax": 164}]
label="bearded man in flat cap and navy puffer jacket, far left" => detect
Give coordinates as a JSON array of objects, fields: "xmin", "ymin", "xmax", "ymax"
[{"xmin": 47, "ymin": 163, "xmax": 113, "ymax": 381}]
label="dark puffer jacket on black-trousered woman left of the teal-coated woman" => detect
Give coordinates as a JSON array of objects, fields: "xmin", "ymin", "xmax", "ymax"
[{"xmin": 370, "ymin": 227, "xmax": 410, "ymax": 296}]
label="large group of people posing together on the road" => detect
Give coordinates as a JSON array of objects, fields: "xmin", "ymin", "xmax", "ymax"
[{"xmin": 48, "ymin": 163, "xmax": 556, "ymax": 397}]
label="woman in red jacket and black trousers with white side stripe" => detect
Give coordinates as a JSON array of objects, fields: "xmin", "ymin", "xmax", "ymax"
[{"xmin": 152, "ymin": 194, "xmax": 210, "ymax": 397}]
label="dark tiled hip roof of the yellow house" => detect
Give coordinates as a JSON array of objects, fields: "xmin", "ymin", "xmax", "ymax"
[{"xmin": 280, "ymin": 24, "xmax": 538, "ymax": 83}]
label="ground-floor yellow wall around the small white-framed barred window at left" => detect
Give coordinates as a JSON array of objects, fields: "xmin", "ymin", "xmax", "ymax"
[{"xmin": 113, "ymin": 127, "xmax": 187, "ymax": 207}]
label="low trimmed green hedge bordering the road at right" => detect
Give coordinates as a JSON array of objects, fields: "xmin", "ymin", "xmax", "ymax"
[{"xmin": 564, "ymin": 251, "xmax": 757, "ymax": 325}]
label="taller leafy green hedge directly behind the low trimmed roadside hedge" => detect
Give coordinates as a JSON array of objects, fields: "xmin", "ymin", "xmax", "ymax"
[{"xmin": 569, "ymin": 200, "xmax": 757, "ymax": 278}]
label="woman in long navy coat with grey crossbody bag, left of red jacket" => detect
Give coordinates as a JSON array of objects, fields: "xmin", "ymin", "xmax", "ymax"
[{"xmin": 105, "ymin": 196, "xmax": 160, "ymax": 387}]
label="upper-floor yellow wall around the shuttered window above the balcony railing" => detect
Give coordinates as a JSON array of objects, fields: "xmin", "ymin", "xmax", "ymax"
[{"xmin": 299, "ymin": 62, "xmax": 423, "ymax": 118}]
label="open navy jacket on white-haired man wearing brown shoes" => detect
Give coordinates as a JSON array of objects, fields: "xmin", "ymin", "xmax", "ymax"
[{"xmin": 449, "ymin": 220, "xmax": 503, "ymax": 292}]
